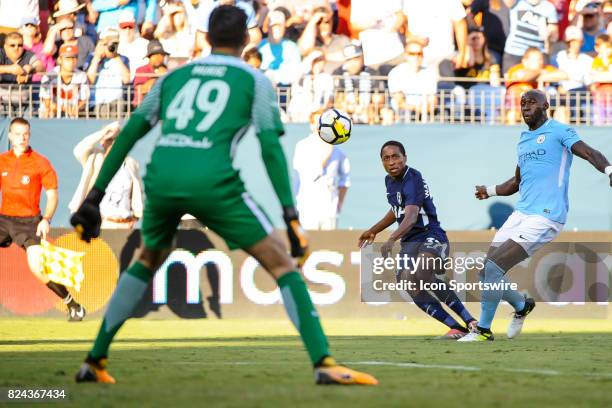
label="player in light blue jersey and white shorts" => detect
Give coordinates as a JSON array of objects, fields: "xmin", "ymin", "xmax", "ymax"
[{"xmin": 458, "ymin": 90, "xmax": 612, "ymax": 341}]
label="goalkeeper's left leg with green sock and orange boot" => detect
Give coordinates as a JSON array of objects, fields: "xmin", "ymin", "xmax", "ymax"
[{"xmin": 76, "ymin": 244, "xmax": 172, "ymax": 384}]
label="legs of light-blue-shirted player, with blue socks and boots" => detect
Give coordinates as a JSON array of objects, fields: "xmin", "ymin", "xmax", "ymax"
[{"xmin": 459, "ymin": 239, "xmax": 535, "ymax": 342}]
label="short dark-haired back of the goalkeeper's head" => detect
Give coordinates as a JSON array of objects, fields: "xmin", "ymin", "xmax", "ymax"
[{"xmin": 208, "ymin": 6, "xmax": 248, "ymax": 48}]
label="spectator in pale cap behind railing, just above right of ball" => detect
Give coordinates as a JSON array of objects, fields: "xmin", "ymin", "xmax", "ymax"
[{"xmin": 333, "ymin": 40, "xmax": 385, "ymax": 123}]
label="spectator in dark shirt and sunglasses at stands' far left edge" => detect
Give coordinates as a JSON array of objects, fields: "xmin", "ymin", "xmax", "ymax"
[{"xmin": 0, "ymin": 31, "xmax": 43, "ymax": 114}]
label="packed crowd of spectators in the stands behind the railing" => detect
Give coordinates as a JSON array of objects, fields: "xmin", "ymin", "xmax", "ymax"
[{"xmin": 0, "ymin": 0, "xmax": 612, "ymax": 124}]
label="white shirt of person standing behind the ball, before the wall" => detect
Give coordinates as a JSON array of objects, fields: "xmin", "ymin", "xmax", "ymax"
[{"xmin": 293, "ymin": 133, "xmax": 351, "ymax": 230}]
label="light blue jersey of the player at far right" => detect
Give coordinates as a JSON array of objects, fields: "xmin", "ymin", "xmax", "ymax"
[{"xmin": 516, "ymin": 119, "xmax": 580, "ymax": 224}]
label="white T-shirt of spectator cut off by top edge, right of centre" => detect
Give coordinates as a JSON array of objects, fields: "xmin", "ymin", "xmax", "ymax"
[{"xmin": 403, "ymin": 0, "xmax": 466, "ymax": 66}]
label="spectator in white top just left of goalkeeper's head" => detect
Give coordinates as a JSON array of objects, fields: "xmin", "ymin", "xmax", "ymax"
[{"xmin": 154, "ymin": 3, "xmax": 195, "ymax": 62}]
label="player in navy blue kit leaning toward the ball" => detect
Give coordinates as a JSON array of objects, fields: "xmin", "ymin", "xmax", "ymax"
[{"xmin": 359, "ymin": 140, "xmax": 476, "ymax": 340}]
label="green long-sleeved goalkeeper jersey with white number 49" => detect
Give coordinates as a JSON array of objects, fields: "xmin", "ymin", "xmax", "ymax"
[{"xmin": 95, "ymin": 54, "xmax": 293, "ymax": 206}]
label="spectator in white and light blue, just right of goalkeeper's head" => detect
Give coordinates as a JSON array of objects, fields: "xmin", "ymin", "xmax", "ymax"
[{"xmin": 259, "ymin": 10, "xmax": 301, "ymax": 86}]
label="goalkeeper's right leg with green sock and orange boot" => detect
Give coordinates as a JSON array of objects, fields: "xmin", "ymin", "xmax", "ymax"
[{"xmin": 246, "ymin": 233, "xmax": 378, "ymax": 385}]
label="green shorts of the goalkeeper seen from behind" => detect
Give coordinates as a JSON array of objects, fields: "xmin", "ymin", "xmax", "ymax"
[{"xmin": 142, "ymin": 187, "xmax": 273, "ymax": 249}]
